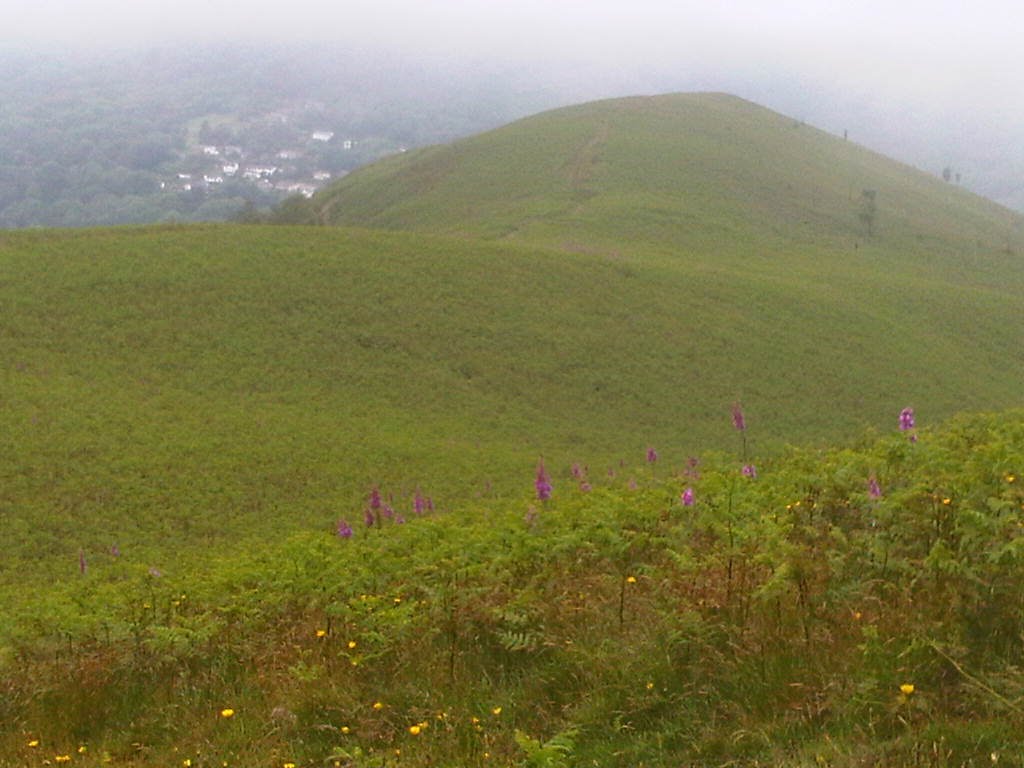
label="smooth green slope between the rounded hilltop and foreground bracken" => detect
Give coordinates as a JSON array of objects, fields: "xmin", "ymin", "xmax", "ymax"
[{"xmin": 6, "ymin": 217, "xmax": 1024, "ymax": 602}]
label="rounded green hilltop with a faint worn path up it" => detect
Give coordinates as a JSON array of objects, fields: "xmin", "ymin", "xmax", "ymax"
[{"xmin": 303, "ymin": 94, "xmax": 1020, "ymax": 261}]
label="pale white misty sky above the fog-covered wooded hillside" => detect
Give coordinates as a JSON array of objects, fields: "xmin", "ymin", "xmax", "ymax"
[{"xmin": 9, "ymin": 0, "xmax": 1024, "ymax": 115}]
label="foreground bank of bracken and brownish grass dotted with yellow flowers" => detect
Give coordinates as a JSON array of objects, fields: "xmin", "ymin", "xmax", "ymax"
[{"xmin": 6, "ymin": 412, "xmax": 1024, "ymax": 766}]
